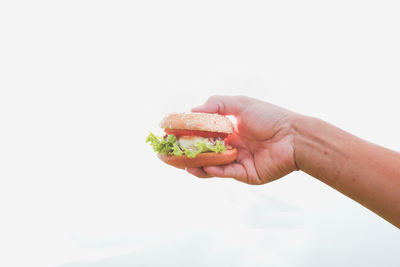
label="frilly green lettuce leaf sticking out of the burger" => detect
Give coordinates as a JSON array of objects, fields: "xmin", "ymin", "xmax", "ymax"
[{"xmin": 146, "ymin": 133, "xmax": 226, "ymax": 158}]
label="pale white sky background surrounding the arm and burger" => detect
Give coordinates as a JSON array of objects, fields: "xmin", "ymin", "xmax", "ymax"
[{"xmin": 0, "ymin": 0, "xmax": 400, "ymax": 267}]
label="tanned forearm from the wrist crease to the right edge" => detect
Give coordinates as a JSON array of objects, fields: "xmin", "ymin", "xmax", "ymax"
[{"xmin": 293, "ymin": 116, "xmax": 400, "ymax": 227}]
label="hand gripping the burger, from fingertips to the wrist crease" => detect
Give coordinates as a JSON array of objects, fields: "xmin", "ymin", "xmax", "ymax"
[{"xmin": 187, "ymin": 96, "xmax": 298, "ymax": 185}]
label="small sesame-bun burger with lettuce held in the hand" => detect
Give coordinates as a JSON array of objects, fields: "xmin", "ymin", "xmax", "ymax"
[{"xmin": 146, "ymin": 113, "xmax": 237, "ymax": 169}]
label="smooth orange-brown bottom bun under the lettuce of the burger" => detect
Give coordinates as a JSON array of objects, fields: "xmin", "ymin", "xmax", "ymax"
[{"xmin": 158, "ymin": 148, "xmax": 237, "ymax": 169}]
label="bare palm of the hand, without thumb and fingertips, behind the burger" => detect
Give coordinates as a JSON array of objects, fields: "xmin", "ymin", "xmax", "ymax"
[{"xmin": 222, "ymin": 105, "xmax": 295, "ymax": 184}]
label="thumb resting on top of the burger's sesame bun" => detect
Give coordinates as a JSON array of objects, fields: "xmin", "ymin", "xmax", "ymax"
[{"xmin": 192, "ymin": 95, "xmax": 250, "ymax": 115}]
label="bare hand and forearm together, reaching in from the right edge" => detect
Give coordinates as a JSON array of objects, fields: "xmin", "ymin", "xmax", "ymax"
[{"xmin": 187, "ymin": 96, "xmax": 400, "ymax": 228}]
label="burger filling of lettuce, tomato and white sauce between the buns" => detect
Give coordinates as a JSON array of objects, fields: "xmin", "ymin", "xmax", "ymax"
[{"xmin": 146, "ymin": 130, "xmax": 230, "ymax": 158}]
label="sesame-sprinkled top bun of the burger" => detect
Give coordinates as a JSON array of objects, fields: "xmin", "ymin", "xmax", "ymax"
[{"xmin": 160, "ymin": 113, "xmax": 233, "ymax": 134}]
